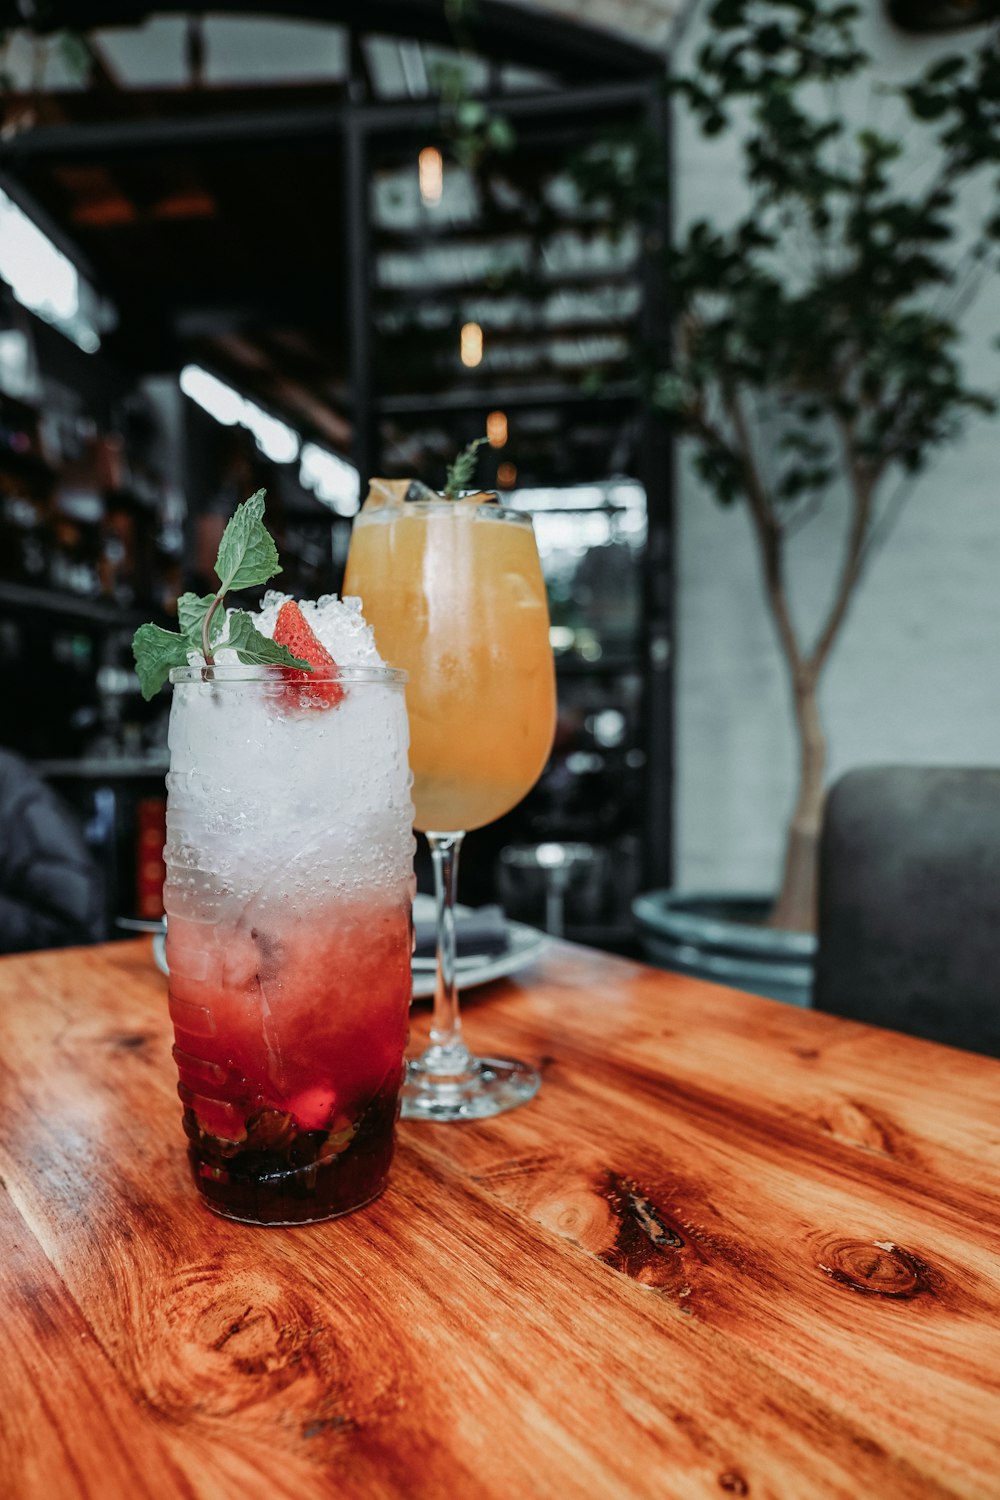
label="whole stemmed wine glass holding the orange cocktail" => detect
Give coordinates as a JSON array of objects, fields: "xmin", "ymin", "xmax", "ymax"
[{"xmin": 343, "ymin": 480, "xmax": 556, "ymax": 1121}]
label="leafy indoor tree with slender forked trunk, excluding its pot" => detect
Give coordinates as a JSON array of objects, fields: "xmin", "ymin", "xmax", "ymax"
[{"xmin": 653, "ymin": 0, "xmax": 1000, "ymax": 929}]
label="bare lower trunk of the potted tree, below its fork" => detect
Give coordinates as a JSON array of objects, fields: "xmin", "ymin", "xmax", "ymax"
[{"xmin": 768, "ymin": 666, "xmax": 826, "ymax": 932}]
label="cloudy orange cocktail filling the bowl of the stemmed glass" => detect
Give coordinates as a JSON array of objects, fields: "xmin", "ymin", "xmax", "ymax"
[{"xmin": 343, "ymin": 498, "xmax": 555, "ymax": 831}]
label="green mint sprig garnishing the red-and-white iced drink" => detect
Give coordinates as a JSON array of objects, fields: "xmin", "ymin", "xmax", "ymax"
[{"xmin": 132, "ymin": 489, "xmax": 312, "ymax": 702}]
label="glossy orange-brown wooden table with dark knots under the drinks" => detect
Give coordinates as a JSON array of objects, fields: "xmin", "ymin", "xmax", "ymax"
[{"xmin": 0, "ymin": 939, "xmax": 1000, "ymax": 1500}]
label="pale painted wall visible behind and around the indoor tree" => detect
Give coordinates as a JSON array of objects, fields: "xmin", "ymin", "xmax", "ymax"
[{"xmin": 676, "ymin": 3, "xmax": 1000, "ymax": 891}]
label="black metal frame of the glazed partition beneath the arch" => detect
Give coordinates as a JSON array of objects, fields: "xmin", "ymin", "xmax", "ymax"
[{"xmin": 0, "ymin": 0, "xmax": 675, "ymax": 885}]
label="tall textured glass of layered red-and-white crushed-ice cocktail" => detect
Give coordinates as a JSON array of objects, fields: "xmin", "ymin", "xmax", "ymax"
[{"xmin": 165, "ymin": 591, "xmax": 412, "ymax": 1224}]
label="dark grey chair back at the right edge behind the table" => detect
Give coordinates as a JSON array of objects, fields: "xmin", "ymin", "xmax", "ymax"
[{"xmin": 813, "ymin": 767, "xmax": 1000, "ymax": 1058}]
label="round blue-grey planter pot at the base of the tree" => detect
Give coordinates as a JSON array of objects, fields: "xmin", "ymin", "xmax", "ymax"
[{"xmin": 633, "ymin": 891, "xmax": 816, "ymax": 1005}]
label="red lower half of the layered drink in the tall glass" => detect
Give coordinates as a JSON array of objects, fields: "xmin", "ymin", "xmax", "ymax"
[{"xmin": 166, "ymin": 890, "xmax": 411, "ymax": 1223}]
